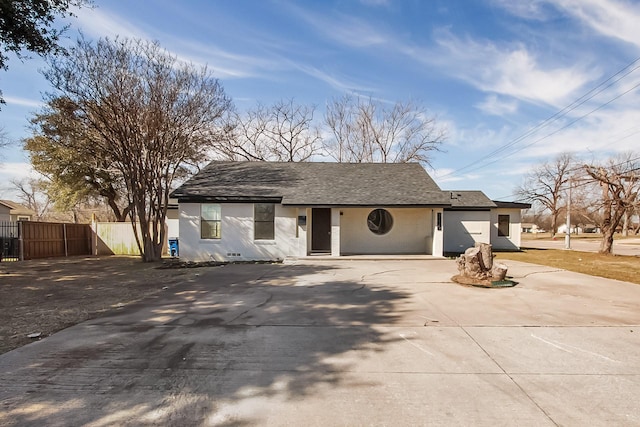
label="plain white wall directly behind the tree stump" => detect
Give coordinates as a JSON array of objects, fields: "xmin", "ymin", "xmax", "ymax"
[{"xmin": 444, "ymin": 211, "xmax": 498, "ymax": 253}]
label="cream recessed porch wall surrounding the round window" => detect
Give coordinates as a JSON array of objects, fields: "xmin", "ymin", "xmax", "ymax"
[{"xmin": 332, "ymin": 208, "xmax": 433, "ymax": 255}]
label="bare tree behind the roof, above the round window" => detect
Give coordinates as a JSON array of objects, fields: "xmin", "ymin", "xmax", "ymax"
[{"xmin": 324, "ymin": 95, "xmax": 446, "ymax": 164}]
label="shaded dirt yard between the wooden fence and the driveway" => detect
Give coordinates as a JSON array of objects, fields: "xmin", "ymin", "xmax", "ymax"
[{"xmin": 0, "ymin": 256, "xmax": 214, "ymax": 354}]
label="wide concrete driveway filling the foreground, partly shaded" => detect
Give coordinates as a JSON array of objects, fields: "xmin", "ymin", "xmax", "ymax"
[{"xmin": 0, "ymin": 259, "xmax": 640, "ymax": 426}]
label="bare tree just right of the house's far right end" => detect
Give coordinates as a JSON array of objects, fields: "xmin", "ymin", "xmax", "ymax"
[{"xmin": 516, "ymin": 153, "xmax": 574, "ymax": 236}]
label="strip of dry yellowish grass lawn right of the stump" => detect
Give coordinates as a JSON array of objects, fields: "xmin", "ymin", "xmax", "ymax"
[{"xmin": 496, "ymin": 249, "xmax": 640, "ymax": 284}]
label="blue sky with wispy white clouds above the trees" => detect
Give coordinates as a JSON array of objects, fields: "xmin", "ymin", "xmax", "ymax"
[{"xmin": 0, "ymin": 0, "xmax": 640, "ymax": 200}]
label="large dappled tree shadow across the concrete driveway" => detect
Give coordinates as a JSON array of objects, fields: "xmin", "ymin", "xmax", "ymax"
[{"xmin": 0, "ymin": 265, "xmax": 408, "ymax": 426}]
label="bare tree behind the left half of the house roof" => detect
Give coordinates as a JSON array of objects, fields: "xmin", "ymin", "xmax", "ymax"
[{"xmin": 216, "ymin": 99, "xmax": 320, "ymax": 162}]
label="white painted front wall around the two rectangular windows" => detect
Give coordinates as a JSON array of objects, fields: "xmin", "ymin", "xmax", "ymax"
[{"xmin": 179, "ymin": 203, "xmax": 306, "ymax": 261}]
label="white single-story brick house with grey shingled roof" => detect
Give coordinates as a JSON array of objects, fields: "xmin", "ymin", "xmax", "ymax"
[{"xmin": 171, "ymin": 161, "xmax": 528, "ymax": 261}]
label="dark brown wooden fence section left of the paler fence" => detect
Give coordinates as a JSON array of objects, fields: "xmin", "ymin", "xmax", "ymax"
[{"xmin": 19, "ymin": 221, "xmax": 92, "ymax": 259}]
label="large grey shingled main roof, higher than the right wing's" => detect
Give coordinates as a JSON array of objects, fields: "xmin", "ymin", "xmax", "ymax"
[{"xmin": 171, "ymin": 161, "xmax": 451, "ymax": 206}]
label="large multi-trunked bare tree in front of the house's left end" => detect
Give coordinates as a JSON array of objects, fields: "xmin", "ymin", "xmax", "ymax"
[{"xmin": 44, "ymin": 39, "xmax": 230, "ymax": 261}]
